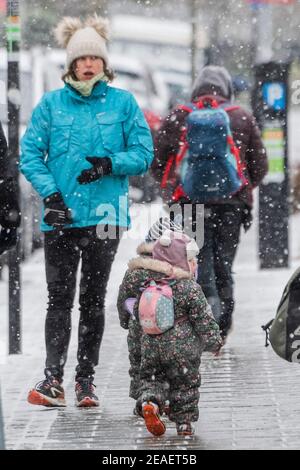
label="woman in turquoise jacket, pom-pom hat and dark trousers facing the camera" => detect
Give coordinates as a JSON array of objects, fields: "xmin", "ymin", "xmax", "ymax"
[{"xmin": 21, "ymin": 15, "xmax": 153, "ymax": 406}]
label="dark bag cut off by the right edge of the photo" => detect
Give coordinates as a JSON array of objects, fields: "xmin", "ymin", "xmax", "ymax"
[{"xmin": 262, "ymin": 268, "xmax": 300, "ymax": 363}]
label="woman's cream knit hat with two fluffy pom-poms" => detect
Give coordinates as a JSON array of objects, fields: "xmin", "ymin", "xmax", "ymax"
[{"xmin": 55, "ymin": 14, "xmax": 109, "ymax": 69}]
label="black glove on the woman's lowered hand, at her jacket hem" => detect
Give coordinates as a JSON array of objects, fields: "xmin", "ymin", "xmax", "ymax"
[{"xmin": 44, "ymin": 193, "xmax": 73, "ymax": 227}]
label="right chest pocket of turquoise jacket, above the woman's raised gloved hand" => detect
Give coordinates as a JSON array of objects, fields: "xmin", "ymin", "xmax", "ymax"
[{"xmin": 96, "ymin": 113, "xmax": 126, "ymax": 153}]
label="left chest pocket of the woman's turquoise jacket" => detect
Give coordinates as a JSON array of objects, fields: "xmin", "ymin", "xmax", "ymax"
[{"xmin": 49, "ymin": 115, "xmax": 74, "ymax": 160}]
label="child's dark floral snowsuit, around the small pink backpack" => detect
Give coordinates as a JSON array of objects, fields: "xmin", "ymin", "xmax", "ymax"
[{"xmin": 118, "ymin": 255, "xmax": 222, "ymax": 423}]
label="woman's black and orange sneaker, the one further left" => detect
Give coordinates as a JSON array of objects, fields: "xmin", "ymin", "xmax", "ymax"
[{"xmin": 27, "ymin": 377, "xmax": 66, "ymax": 406}]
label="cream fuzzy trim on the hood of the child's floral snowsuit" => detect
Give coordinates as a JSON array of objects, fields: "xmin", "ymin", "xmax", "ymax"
[{"xmin": 128, "ymin": 256, "xmax": 193, "ymax": 280}]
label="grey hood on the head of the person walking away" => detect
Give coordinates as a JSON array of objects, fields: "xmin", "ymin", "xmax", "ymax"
[{"xmin": 191, "ymin": 65, "xmax": 233, "ymax": 101}]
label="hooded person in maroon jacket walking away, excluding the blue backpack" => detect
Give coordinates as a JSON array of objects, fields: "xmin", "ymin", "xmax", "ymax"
[{"xmin": 152, "ymin": 65, "xmax": 268, "ymax": 338}]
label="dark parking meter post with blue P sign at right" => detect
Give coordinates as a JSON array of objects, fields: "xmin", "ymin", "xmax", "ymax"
[{"xmin": 253, "ymin": 62, "xmax": 289, "ymax": 269}]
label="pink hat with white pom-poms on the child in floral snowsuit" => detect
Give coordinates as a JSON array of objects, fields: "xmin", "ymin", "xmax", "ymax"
[{"xmin": 152, "ymin": 230, "xmax": 199, "ymax": 272}]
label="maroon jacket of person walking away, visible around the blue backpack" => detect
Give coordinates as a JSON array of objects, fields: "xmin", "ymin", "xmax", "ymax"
[{"xmin": 151, "ymin": 93, "xmax": 268, "ymax": 207}]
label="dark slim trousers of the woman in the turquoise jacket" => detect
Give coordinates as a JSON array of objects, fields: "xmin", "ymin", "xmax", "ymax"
[{"xmin": 45, "ymin": 227, "xmax": 120, "ymax": 379}]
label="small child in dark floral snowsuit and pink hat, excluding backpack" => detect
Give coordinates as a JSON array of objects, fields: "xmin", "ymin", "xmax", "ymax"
[{"xmin": 118, "ymin": 231, "xmax": 222, "ymax": 435}]
